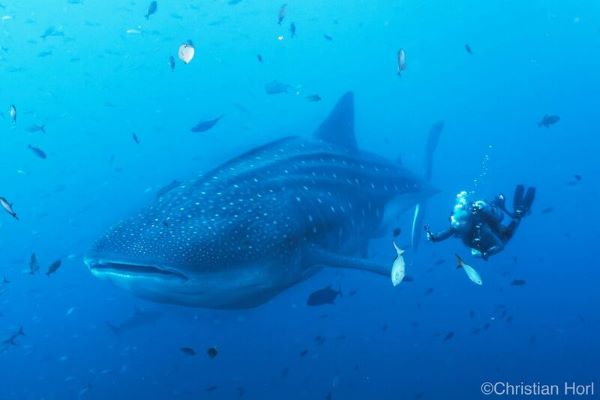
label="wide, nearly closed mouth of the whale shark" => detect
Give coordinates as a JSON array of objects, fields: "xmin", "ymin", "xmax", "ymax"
[{"xmin": 85, "ymin": 259, "xmax": 188, "ymax": 281}]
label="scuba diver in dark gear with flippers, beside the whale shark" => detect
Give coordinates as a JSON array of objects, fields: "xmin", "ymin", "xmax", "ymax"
[{"xmin": 425, "ymin": 185, "xmax": 535, "ymax": 260}]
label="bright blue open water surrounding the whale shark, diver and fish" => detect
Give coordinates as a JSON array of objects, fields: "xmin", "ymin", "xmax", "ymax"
[{"xmin": 0, "ymin": 0, "xmax": 600, "ymax": 400}]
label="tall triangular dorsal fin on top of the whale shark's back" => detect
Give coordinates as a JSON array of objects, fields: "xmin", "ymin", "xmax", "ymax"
[{"xmin": 315, "ymin": 92, "xmax": 357, "ymax": 149}]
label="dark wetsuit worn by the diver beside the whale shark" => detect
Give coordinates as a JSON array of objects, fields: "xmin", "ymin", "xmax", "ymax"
[{"xmin": 427, "ymin": 197, "xmax": 522, "ymax": 260}]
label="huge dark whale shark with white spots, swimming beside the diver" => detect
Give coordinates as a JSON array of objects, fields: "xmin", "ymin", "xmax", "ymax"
[{"xmin": 84, "ymin": 92, "xmax": 435, "ymax": 309}]
